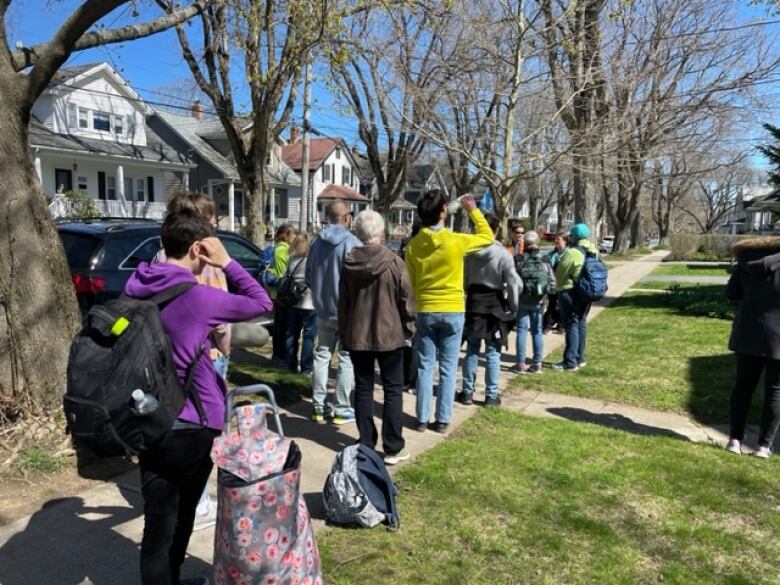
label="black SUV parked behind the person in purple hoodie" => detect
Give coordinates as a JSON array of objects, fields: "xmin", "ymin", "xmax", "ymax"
[{"xmin": 56, "ymin": 219, "xmax": 273, "ymax": 324}]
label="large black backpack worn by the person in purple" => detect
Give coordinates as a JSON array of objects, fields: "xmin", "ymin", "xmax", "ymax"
[{"xmin": 63, "ymin": 283, "xmax": 205, "ymax": 456}]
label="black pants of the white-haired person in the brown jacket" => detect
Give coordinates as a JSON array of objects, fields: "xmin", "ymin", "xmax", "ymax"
[{"xmin": 349, "ymin": 348, "xmax": 405, "ymax": 455}]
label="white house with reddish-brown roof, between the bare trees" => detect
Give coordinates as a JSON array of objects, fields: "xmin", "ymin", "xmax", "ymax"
[{"xmin": 281, "ymin": 135, "xmax": 370, "ymax": 224}]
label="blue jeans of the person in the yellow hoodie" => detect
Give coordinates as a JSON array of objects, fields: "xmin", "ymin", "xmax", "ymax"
[{"xmin": 416, "ymin": 313, "xmax": 466, "ymax": 423}]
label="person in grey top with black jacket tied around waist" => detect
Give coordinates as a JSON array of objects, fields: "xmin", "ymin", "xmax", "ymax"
[{"xmin": 456, "ymin": 213, "xmax": 523, "ymax": 407}]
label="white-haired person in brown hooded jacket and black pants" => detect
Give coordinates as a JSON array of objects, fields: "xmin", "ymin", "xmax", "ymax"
[{"xmin": 339, "ymin": 210, "xmax": 415, "ymax": 465}]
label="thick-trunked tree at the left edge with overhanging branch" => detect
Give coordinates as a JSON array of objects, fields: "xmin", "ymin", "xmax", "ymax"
[{"xmin": 0, "ymin": 0, "xmax": 208, "ymax": 416}]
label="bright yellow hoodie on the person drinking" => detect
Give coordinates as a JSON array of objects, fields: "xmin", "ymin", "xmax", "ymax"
[{"xmin": 406, "ymin": 209, "xmax": 495, "ymax": 313}]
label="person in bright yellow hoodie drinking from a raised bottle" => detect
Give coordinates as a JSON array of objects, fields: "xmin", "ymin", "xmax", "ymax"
[{"xmin": 405, "ymin": 189, "xmax": 494, "ymax": 433}]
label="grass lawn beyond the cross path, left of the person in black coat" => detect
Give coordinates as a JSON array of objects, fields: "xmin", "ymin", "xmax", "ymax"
[{"xmin": 514, "ymin": 290, "xmax": 740, "ymax": 423}]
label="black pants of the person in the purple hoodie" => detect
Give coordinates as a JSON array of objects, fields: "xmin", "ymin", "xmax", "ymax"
[{"xmin": 140, "ymin": 428, "xmax": 218, "ymax": 585}]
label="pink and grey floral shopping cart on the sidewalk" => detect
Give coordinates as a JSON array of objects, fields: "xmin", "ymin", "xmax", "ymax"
[{"xmin": 211, "ymin": 384, "xmax": 322, "ymax": 585}]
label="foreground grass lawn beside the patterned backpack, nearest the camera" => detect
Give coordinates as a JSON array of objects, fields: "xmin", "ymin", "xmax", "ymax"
[{"xmin": 318, "ymin": 409, "xmax": 780, "ymax": 585}]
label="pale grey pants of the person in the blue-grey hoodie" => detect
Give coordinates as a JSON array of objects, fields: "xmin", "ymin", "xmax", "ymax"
[{"xmin": 311, "ymin": 318, "xmax": 355, "ymax": 416}]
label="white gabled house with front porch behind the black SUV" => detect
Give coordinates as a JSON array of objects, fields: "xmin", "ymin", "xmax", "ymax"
[{"xmin": 35, "ymin": 63, "xmax": 191, "ymax": 219}]
